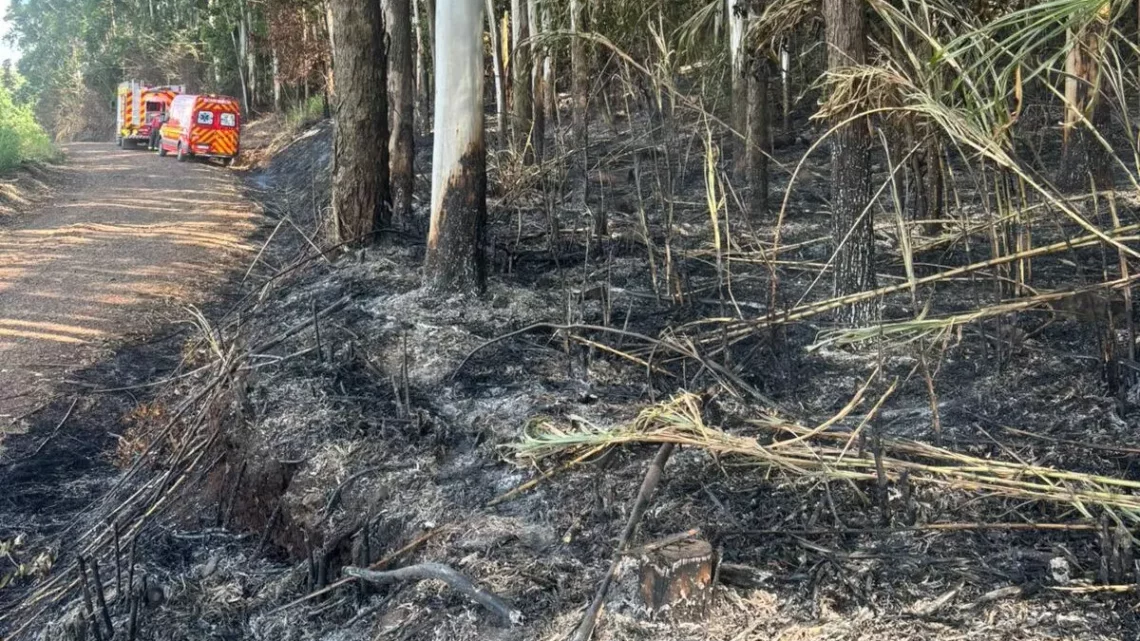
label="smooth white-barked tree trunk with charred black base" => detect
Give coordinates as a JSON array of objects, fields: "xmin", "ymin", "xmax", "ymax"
[{"xmin": 424, "ymin": 0, "xmax": 487, "ymax": 292}]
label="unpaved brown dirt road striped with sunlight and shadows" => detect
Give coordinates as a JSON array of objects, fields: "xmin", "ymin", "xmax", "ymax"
[{"xmin": 0, "ymin": 144, "xmax": 259, "ymax": 431}]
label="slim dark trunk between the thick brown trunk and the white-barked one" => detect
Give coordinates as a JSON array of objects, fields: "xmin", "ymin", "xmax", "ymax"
[{"xmin": 384, "ymin": 0, "xmax": 416, "ymax": 229}]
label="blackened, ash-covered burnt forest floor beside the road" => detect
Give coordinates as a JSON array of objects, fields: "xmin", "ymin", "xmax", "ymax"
[{"xmin": 0, "ymin": 102, "xmax": 1140, "ymax": 641}]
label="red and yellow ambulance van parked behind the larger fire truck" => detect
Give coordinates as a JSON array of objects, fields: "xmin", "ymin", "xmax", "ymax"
[{"xmin": 158, "ymin": 94, "xmax": 242, "ymax": 164}]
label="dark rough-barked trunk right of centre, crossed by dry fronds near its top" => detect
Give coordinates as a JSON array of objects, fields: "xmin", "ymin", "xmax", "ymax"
[{"xmin": 823, "ymin": 0, "xmax": 877, "ymax": 325}]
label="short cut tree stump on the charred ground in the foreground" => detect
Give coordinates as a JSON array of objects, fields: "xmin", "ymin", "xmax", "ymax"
[{"xmin": 641, "ymin": 538, "xmax": 716, "ymax": 618}]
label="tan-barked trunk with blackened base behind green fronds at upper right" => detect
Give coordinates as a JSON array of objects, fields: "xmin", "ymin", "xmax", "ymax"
[{"xmin": 1057, "ymin": 2, "xmax": 1113, "ymax": 190}]
